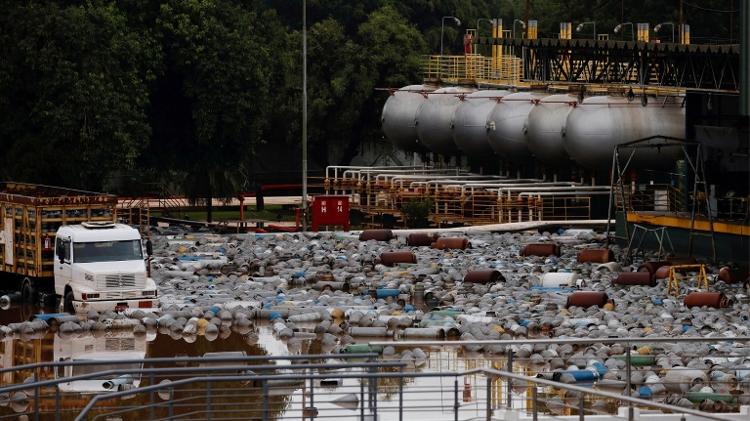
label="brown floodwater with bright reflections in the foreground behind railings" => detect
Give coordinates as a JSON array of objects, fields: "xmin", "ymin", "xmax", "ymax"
[{"xmin": 0, "ymin": 306, "xmax": 615, "ymax": 420}]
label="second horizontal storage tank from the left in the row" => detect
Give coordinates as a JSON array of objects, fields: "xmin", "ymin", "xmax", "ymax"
[{"xmin": 417, "ymin": 87, "xmax": 474, "ymax": 156}]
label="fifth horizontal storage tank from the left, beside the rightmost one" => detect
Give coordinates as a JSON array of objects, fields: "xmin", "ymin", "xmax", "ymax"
[{"xmin": 526, "ymin": 94, "xmax": 578, "ymax": 167}]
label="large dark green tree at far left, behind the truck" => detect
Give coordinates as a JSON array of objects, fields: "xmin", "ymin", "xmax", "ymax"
[{"xmin": 0, "ymin": 0, "xmax": 159, "ymax": 189}]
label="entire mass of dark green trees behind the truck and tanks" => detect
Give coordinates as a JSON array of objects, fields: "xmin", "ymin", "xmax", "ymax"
[{"xmin": 0, "ymin": 0, "xmax": 738, "ymax": 197}]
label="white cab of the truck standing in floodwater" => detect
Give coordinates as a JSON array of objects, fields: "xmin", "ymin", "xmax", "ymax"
[{"xmin": 54, "ymin": 222, "xmax": 159, "ymax": 313}]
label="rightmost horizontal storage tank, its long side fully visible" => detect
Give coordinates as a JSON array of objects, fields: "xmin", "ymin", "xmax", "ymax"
[{"xmin": 564, "ymin": 96, "xmax": 685, "ymax": 169}]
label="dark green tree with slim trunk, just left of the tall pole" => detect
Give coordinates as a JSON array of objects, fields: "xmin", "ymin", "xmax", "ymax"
[{"xmin": 154, "ymin": 0, "xmax": 271, "ymax": 220}]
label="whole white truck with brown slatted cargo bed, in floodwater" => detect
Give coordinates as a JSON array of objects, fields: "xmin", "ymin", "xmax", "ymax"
[{"xmin": 0, "ymin": 182, "xmax": 159, "ymax": 313}]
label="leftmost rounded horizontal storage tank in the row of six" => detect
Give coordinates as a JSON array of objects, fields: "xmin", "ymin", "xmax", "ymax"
[{"xmin": 380, "ymin": 85, "xmax": 435, "ymax": 152}]
